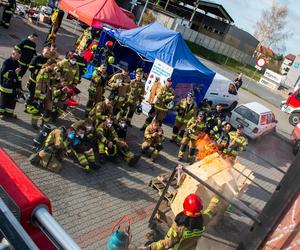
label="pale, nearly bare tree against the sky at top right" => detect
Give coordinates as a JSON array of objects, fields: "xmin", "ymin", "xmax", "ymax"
[{"xmin": 254, "ymin": 0, "xmax": 293, "ymax": 53}]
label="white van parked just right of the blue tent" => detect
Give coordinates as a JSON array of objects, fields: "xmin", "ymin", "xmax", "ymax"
[{"xmin": 204, "ymin": 73, "xmax": 239, "ymax": 111}]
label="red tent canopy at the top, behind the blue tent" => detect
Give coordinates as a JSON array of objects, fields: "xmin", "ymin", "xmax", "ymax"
[{"xmin": 59, "ymin": 0, "xmax": 137, "ymax": 29}]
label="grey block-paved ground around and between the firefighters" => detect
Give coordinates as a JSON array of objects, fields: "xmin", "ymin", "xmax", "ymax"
[{"xmin": 0, "ymin": 14, "xmax": 294, "ymax": 249}]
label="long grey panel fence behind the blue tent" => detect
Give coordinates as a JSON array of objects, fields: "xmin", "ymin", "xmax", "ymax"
[{"xmin": 174, "ymin": 23, "xmax": 255, "ymax": 66}]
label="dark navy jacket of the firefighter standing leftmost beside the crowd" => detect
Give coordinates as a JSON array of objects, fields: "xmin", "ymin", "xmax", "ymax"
[{"xmin": 0, "ymin": 58, "xmax": 22, "ymax": 94}]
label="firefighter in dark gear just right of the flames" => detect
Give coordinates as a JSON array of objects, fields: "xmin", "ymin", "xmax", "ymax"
[{"xmin": 210, "ymin": 122, "xmax": 231, "ymax": 154}]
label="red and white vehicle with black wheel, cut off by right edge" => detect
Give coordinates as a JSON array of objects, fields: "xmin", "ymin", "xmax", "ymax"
[{"xmin": 281, "ymin": 89, "xmax": 300, "ymax": 126}]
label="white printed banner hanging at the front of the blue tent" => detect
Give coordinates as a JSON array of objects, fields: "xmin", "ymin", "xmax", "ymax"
[{"xmin": 143, "ymin": 59, "xmax": 174, "ymax": 113}]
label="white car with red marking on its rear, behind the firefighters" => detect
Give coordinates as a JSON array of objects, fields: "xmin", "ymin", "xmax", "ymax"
[{"xmin": 228, "ymin": 102, "xmax": 277, "ymax": 139}]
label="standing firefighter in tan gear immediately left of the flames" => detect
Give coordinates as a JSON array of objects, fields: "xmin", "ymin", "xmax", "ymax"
[{"xmin": 178, "ymin": 111, "xmax": 207, "ymax": 163}]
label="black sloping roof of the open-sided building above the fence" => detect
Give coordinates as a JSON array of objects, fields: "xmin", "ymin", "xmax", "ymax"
[{"xmin": 172, "ymin": 0, "xmax": 234, "ymax": 23}]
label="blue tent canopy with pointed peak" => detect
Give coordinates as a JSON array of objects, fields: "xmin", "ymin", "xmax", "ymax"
[{"xmin": 108, "ymin": 23, "xmax": 215, "ymax": 81}]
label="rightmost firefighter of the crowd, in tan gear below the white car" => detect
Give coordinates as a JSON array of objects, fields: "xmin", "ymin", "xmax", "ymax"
[{"xmin": 227, "ymin": 124, "xmax": 248, "ymax": 157}]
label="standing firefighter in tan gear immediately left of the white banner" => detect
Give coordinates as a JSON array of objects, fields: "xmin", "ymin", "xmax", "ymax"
[{"xmin": 126, "ymin": 68, "xmax": 145, "ymax": 127}]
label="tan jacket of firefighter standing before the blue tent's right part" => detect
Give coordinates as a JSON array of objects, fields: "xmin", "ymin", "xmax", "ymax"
[{"xmin": 176, "ymin": 98, "xmax": 197, "ymax": 124}]
